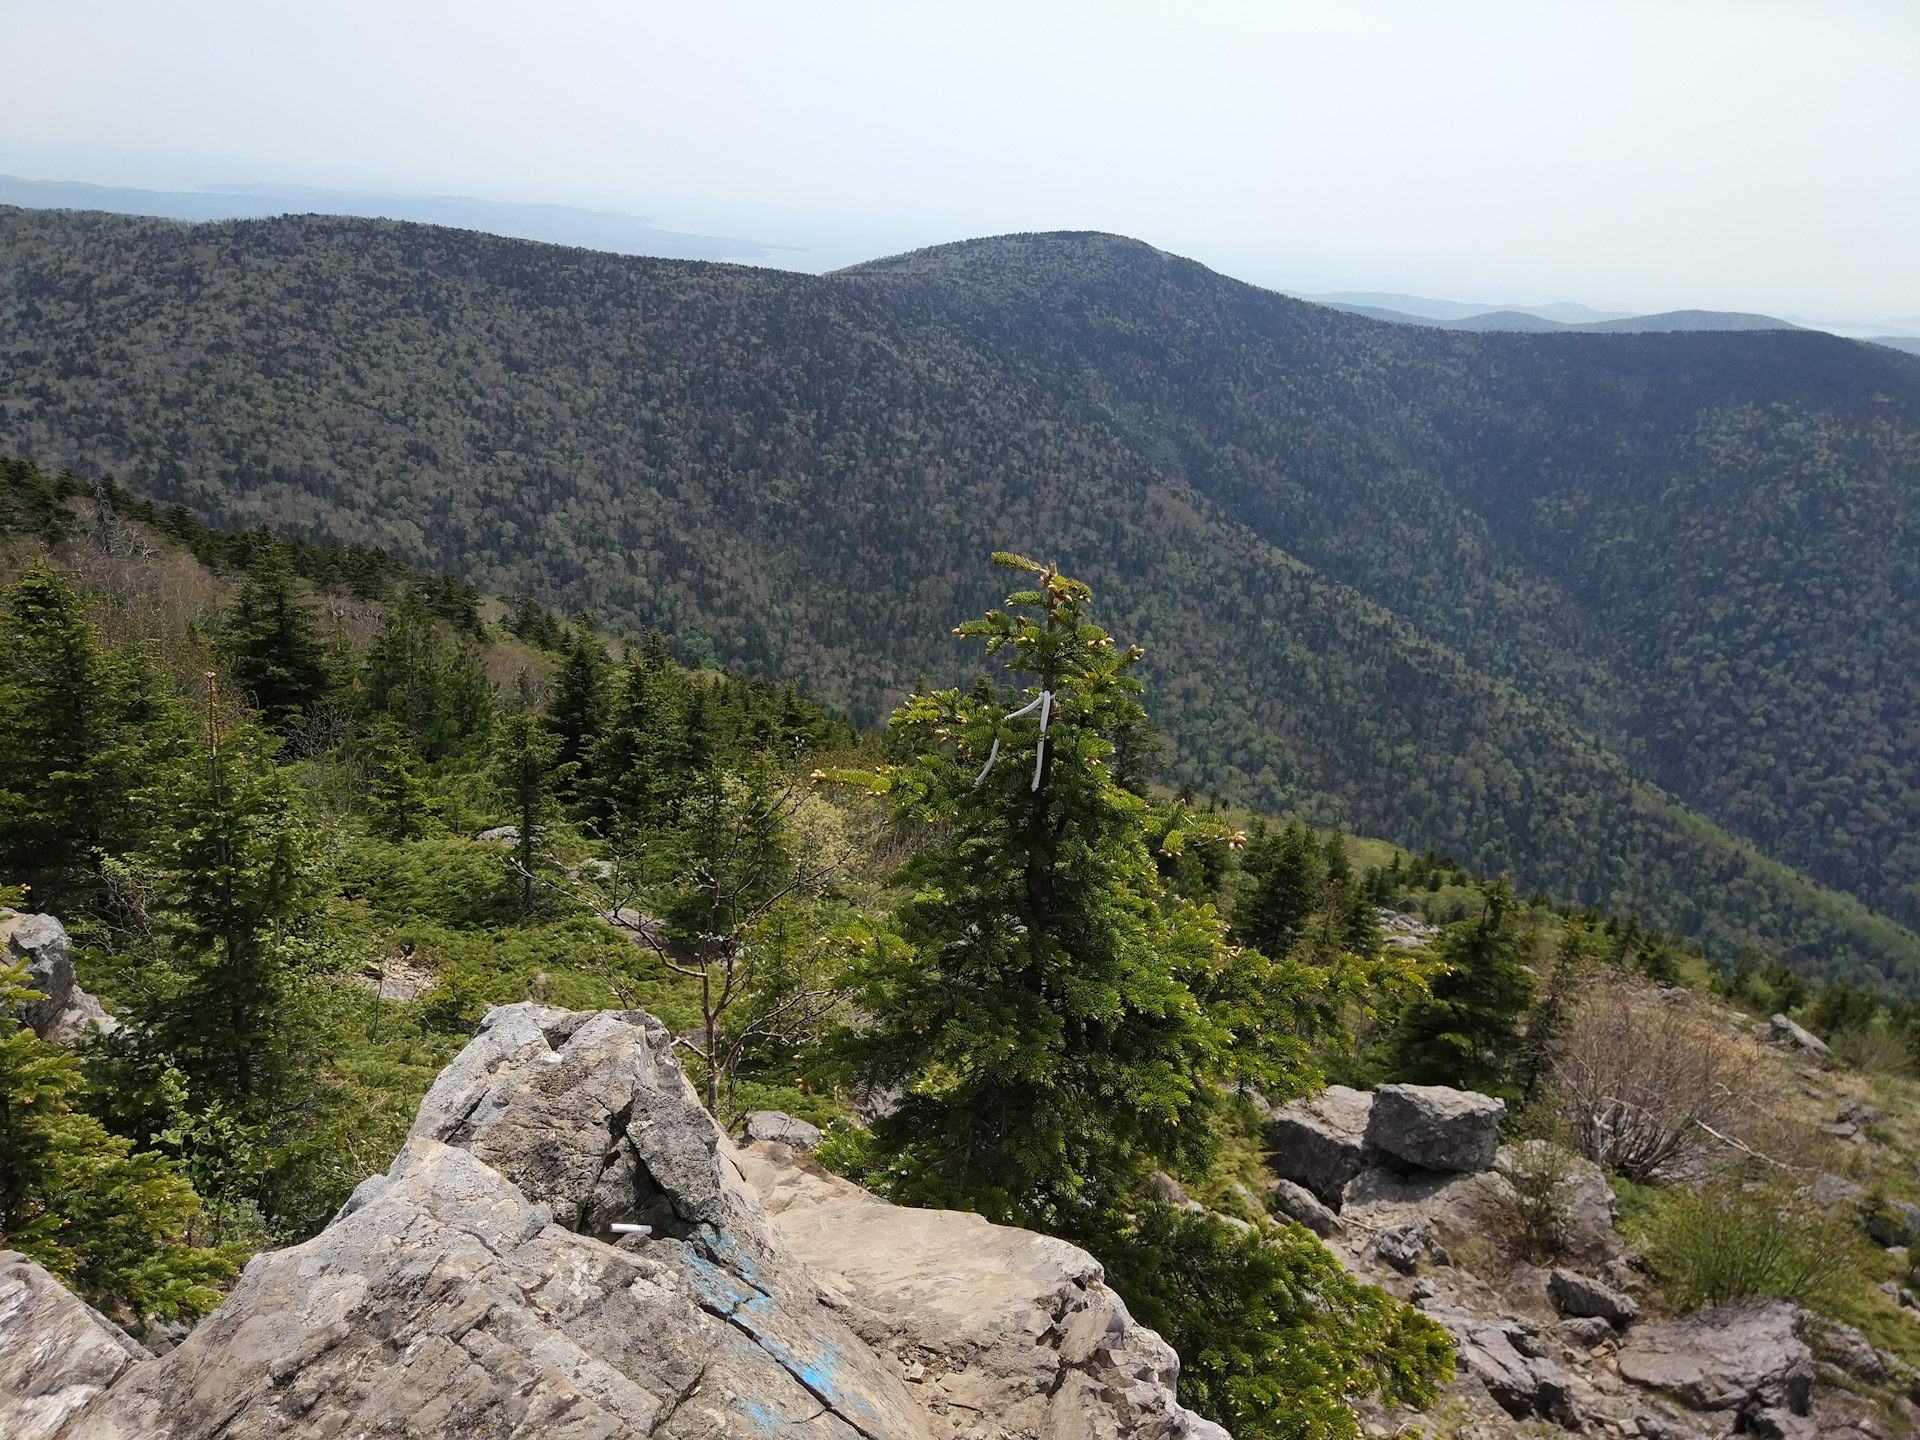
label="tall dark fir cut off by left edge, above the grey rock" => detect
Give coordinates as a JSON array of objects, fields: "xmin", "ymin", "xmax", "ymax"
[{"xmin": 0, "ymin": 561, "xmax": 175, "ymax": 914}]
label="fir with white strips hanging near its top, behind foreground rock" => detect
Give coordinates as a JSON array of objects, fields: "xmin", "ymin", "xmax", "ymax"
[{"xmin": 820, "ymin": 555, "xmax": 1452, "ymax": 1440}]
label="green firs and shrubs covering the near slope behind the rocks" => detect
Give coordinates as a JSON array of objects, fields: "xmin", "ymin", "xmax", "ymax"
[{"xmin": 0, "ymin": 487, "xmax": 1920, "ymax": 1440}]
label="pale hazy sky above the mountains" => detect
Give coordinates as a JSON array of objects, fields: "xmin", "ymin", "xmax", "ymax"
[{"xmin": 0, "ymin": 0, "xmax": 1920, "ymax": 317}]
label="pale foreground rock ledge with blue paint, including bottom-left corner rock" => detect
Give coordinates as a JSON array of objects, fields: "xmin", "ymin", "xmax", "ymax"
[{"xmin": 0, "ymin": 1004, "xmax": 1229, "ymax": 1440}]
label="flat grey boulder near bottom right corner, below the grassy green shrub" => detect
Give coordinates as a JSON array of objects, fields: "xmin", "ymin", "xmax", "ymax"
[{"xmin": 1619, "ymin": 1296, "xmax": 1812, "ymax": 1428}]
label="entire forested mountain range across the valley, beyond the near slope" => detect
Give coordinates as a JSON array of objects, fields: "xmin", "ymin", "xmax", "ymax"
[{"xmin": 0, "ymin": 211, "xmax": 1920, "ymax": 987}]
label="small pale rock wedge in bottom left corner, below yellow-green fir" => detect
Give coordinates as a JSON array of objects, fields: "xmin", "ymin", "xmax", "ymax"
[{"xmin": 0, "ymin": 1250, "xmax": 150, "ymax": 1440}]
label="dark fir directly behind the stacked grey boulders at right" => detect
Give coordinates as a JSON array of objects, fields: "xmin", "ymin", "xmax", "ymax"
[{"xmin": 1390, "ymin": 879, "xmax": 1534, "ymax": 1094}]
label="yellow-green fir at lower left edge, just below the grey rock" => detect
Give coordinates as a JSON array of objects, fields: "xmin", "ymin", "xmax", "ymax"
[{"xmin": 0, "ymin": 964, "xmax": 234, "ymax": 1319}]
